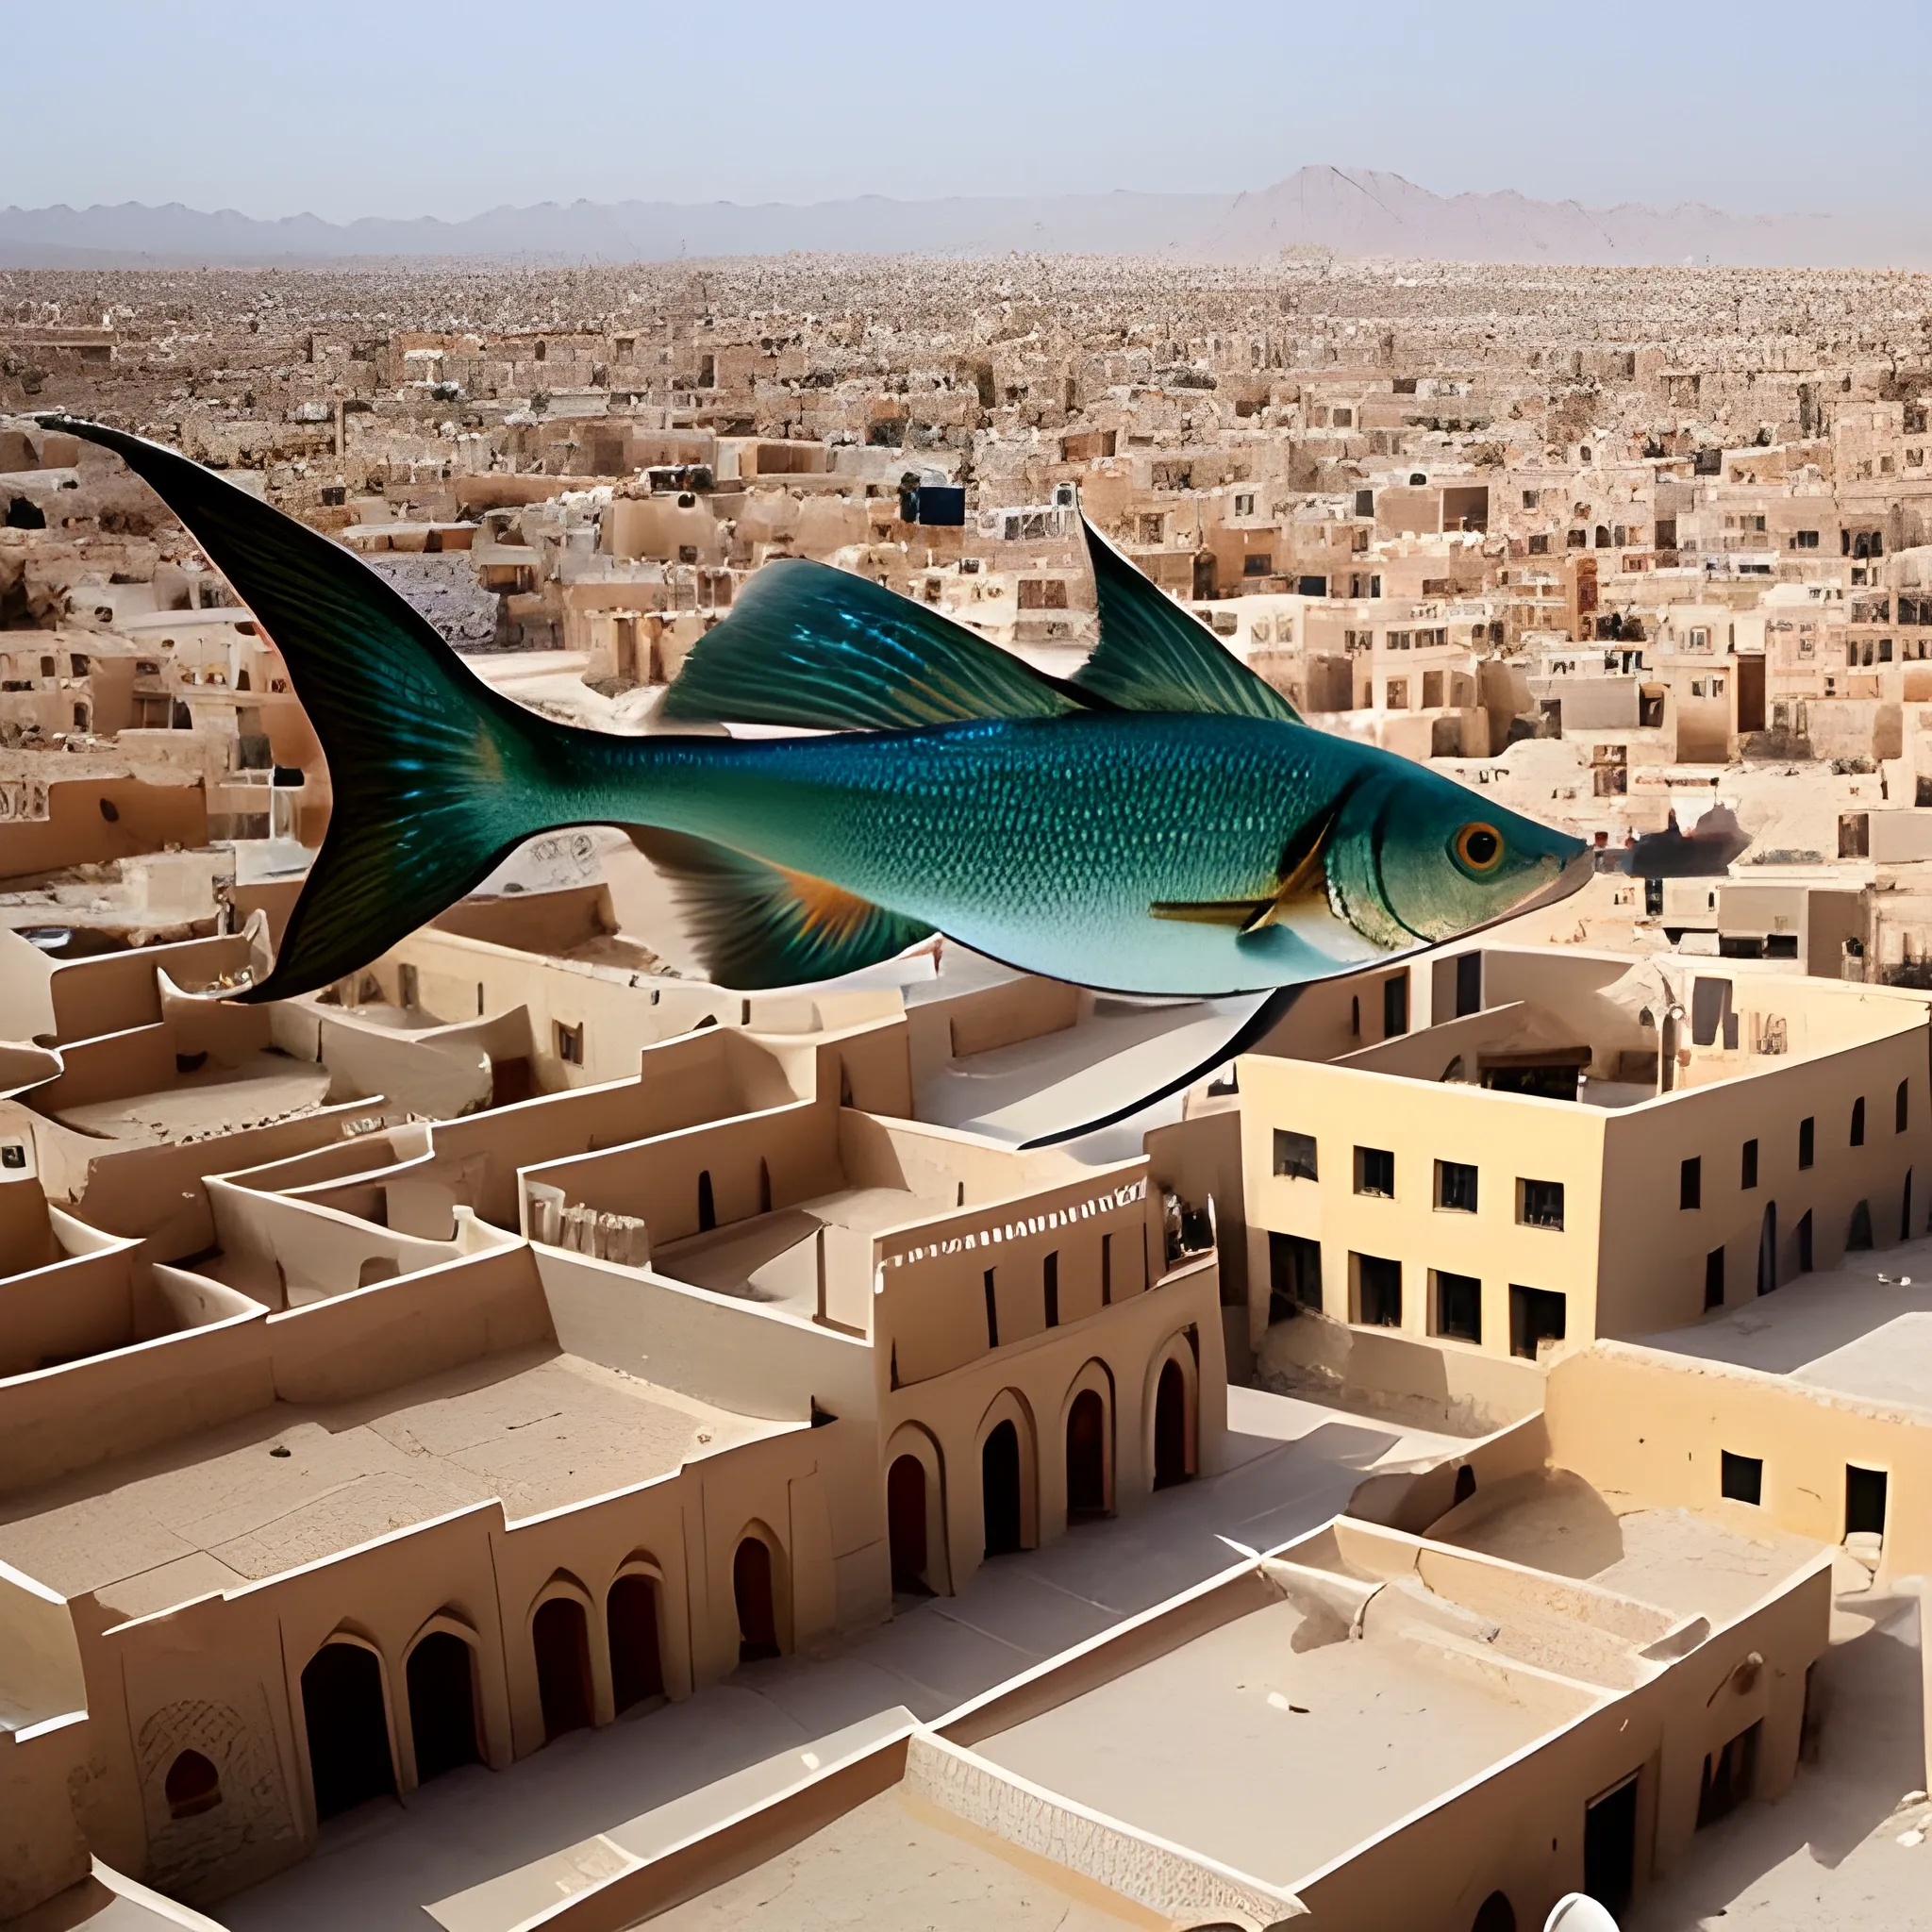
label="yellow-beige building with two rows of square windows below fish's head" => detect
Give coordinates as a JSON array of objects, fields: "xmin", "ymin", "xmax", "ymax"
[{"xmin": 1239, "ymin": 947, "xmax": 1932, "ymax": 1420}]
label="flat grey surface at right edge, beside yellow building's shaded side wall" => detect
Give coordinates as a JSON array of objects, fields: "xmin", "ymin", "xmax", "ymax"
[{"xmin": 1635, "ymin": 1239, "xmax": 1932, "ymax": 1410}]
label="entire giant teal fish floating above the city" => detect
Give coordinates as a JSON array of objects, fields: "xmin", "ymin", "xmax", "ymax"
[{"xmin": 42, "ymin": 415, "xmax": 1591, "ymax": 1138}]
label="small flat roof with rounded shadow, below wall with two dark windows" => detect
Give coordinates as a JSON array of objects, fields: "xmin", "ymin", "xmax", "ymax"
[{"xmin": 1430, "ymin": 1471, "xmax": 1818, "ymax": 1624}]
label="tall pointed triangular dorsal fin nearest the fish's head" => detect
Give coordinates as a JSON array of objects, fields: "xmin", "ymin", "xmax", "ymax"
[{"xmin": 1073, "ymin": 518, "xmax": 1300, "ymax": 724}]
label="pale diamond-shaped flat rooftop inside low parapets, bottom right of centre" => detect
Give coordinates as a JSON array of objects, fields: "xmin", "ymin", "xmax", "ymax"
[{"xmin": 972, "ymin": 1602, "xmax": 1596, "ymax": 1890}]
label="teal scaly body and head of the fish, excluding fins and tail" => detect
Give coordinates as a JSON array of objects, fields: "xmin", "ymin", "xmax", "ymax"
[{"xmin": 555, "ymin": 711, "xmax": 1578, "ymax": 997}]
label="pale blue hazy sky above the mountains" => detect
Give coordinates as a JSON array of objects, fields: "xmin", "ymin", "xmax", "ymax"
[{"xmin": 0, "ymin": 0, "xmax": 1932, "ymax": 220}]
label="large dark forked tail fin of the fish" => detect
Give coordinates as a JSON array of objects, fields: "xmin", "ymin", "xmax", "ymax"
[{"xmin": 48, "ymin": 417, "xmax": 572, "ymax": 1001}]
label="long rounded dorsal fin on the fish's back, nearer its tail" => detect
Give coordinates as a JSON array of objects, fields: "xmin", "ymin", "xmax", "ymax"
[{"xmin": 662, "ymin": 557, "xmax": 1088, "ymax": 730}]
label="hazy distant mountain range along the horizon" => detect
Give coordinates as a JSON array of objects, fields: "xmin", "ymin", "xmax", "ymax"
[{"xmin": 0, "ymin": 166, "xmax": 1901, "ymax": 269}]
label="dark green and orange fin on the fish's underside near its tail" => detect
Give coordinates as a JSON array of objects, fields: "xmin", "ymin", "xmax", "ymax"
[{"xmin": 630, "ymin": 824, "xmax": 933, "ymax": 993}]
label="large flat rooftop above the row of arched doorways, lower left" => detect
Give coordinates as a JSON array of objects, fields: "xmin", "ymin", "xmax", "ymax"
[{"xmin": 0, "ymin": 1351, "xmax": 791, "ymax": 1617}]
